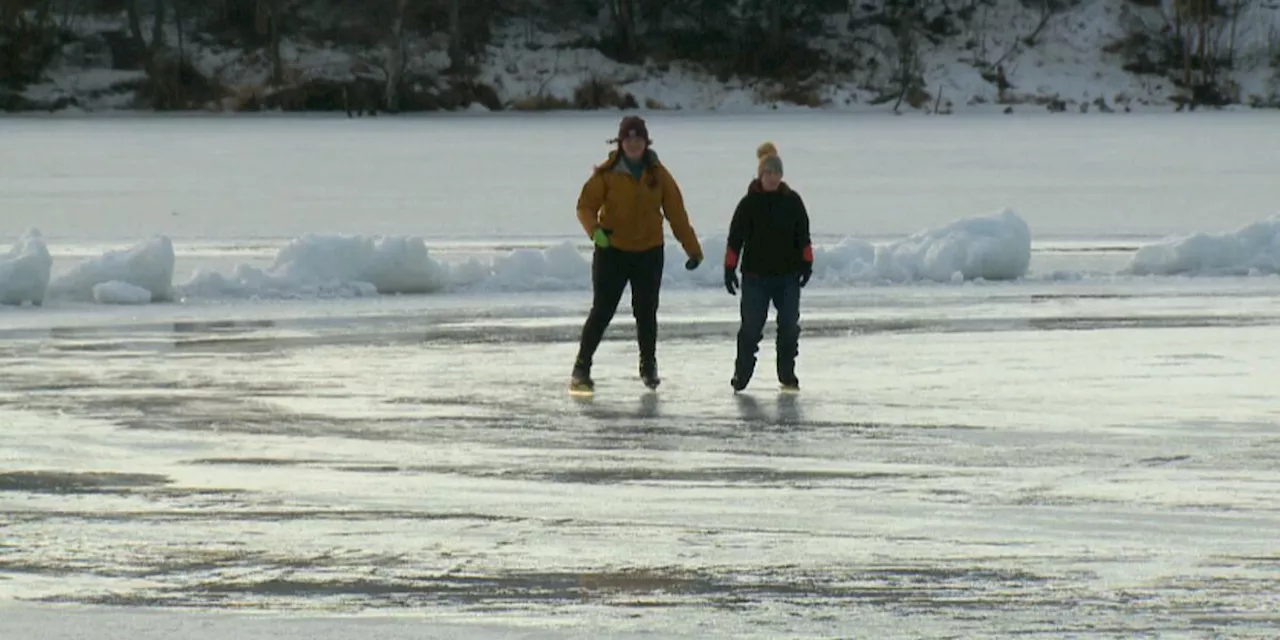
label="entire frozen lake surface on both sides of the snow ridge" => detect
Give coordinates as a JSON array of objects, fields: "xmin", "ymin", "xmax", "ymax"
[{"xmin": 0, "ymin": 114, "xmax": 1280, "ymax": 640}]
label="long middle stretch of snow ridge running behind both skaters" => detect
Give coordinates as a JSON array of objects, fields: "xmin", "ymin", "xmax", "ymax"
[{"xmin": 167, "ymin": 211, "xmax": 1030, "ymax": 298}]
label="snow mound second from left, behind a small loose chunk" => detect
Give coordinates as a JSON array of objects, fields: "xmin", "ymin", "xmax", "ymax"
[{"xmin": 49, "ymin": 236, "xmax": 174, "ymax": 302}]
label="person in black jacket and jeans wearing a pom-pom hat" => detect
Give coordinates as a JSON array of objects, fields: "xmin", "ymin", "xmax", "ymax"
[{"xmin": 724, "ymin": 142, "xmax": 813, "ymax": 392}]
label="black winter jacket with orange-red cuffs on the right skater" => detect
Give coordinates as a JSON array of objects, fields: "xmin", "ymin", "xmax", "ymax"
[{"xmin": 724, "ymin": 179, "xmax": 813, "ymax": 275}]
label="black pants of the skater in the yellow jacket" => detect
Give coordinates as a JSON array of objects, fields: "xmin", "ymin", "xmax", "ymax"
[{"xmin": 575, "ymin": 247, "xmax": 664, "ymax": 369}]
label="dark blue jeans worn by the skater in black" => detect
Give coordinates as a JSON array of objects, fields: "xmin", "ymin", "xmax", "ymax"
[{"xmin": 733, "ymin": 274, "xmax": 800, "ymax": 383}]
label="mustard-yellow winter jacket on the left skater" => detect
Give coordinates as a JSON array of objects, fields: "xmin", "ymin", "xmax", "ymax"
[{"xmin": 577, "ymin": 150, "xmax": 703, "ymax": 260}]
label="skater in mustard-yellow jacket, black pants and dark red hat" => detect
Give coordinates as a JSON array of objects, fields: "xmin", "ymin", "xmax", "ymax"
[{"xmin": 570, "ymin": 115, "xmax": 703, "ymax": 392}]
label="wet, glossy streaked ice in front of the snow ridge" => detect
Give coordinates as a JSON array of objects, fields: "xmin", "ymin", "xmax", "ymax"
[{"xmin": 0, "ymin": 278, "xmax": 1280, "ymax": 640}]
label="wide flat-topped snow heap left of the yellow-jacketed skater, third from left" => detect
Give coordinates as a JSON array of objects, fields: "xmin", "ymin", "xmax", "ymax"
[{"xmin": 179, "ymin": 234, "xmax": 448, "ymax": 297}]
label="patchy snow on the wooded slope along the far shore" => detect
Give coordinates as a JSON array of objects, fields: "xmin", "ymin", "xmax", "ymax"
[{"xmin": 10, "ymin": 0, "xmax": 1280, "ymax": 111}]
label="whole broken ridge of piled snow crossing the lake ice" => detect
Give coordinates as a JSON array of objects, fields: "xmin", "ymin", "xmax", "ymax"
[{"xmin": 15, "ymin": 210, "xmax": 1280, "ymax": 305}]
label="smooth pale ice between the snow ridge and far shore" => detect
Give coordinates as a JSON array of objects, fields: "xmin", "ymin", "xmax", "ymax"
[{"xmin": 0, "ymin": 112, "xmax": 1280, "ymax": 244}]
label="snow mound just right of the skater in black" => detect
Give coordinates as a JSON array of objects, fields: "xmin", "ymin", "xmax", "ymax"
[{"xmin": 814, "ymin": 210, "xmax": 1032, "ymax": 283}]
